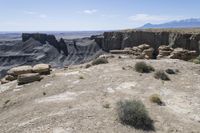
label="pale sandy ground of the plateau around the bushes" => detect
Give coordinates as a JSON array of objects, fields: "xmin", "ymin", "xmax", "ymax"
[{"xmin": 0, "ymin": 56, "xmax": 200, "ymax": 133}]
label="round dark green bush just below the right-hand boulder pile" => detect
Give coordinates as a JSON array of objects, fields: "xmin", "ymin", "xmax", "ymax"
[{"xmin": 135, "ymin": 62, "xmax": 155, "ymax": 73}]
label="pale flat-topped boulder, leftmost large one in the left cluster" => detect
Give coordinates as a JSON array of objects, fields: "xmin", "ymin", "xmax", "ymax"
[{"xmin": 7, "ymin": 66, "xmax": 32, "ymax": 76}]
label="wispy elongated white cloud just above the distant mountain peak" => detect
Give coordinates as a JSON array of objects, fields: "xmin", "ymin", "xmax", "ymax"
[{"xmin": 129, "ymin": 14, "xmax": 184, "ymax": 24}]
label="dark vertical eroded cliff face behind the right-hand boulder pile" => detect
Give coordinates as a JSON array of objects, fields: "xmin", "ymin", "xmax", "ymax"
[{"xmin": 98, "ymin": 30, "xmax": 200, "ymax": 53}]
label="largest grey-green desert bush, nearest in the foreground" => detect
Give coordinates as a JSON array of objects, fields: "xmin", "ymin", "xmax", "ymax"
[{"xmin": 117, "ymin": 100, "xmax": 154, "ymax": 130}]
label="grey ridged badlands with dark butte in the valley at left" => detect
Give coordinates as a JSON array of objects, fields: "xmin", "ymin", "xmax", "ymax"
[{"xmin": 0, "ymin": 34, "xmax": 103, "ymax": 77}]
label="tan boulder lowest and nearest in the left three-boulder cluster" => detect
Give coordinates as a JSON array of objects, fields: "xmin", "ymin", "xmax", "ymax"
[{"xmin": 17, "ymin": 73, "xmax": 42, "ymax": 85}]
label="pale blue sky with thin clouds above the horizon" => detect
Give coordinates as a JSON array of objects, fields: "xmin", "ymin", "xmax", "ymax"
[{"xmin": 0, "ymin": 0, "xmax": 200, "ymax": 31}]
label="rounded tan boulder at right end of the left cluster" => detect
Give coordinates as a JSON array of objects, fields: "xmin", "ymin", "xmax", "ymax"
[{"xmin": 33, "ymin": 64, "xmax": 51, "ymax": 74}]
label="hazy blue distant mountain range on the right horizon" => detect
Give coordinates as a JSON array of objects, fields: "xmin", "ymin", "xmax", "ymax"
[{"xmin": 140, "ymin": 18, "xmax": 200, "ymax": 29}]
